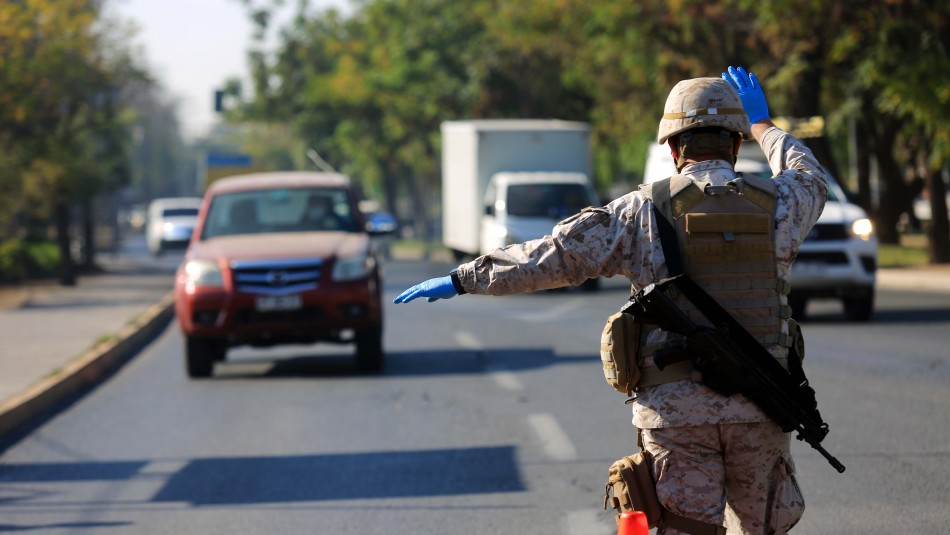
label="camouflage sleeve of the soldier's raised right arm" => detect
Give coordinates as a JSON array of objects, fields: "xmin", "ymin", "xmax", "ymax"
[{"xmin": 762, "ymin": 127, "xmax": 828, "ymax": 266}]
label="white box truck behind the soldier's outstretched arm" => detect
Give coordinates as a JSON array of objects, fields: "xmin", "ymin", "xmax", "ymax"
[{"xmin": 441, "ymin": 119, "xmax": 599, "ymax": 261}]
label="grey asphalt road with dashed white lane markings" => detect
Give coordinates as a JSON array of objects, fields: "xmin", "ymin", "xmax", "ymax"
[{"xmin": 0, "ymin": 260, "xmax": 950, "ymax": 535}]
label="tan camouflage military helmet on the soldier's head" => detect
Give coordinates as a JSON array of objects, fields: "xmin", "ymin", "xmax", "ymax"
[{"xmin": 656, "ymin": 78, "xmax": 752, "ymax": 145}]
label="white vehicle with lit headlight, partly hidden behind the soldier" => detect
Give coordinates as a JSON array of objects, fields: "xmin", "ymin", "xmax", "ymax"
[{"xmin": 643, "ymin": 142, "xmax": 878, "ymax": 321}]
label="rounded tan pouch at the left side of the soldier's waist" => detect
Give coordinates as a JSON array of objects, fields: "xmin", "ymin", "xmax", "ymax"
[{"xmin": 600, "ymin": 311, "xmax": 646, "ymax": 396}]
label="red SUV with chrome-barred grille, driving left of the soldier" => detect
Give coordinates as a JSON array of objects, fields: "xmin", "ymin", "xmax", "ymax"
[{"xmin": 175, "ymin": 172, "xmax": 383, "ymax": 377}]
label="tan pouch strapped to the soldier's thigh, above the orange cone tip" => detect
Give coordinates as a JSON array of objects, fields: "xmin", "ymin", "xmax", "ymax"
[{"xmin": 604, "ymin": 450, "xmax": 663, "ymax": 528}]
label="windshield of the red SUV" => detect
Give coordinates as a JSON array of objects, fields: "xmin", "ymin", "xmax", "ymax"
[{"xmin": 201, "ymin": 188, "xmax": 359, "ymax": 240}]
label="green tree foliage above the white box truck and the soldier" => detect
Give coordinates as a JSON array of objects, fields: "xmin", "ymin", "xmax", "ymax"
[{"xmin": 231, "ymin": 0, "xmax": 950, "ymax": 256}]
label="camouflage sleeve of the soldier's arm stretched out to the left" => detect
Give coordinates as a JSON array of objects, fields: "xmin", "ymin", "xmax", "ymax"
[{"xmin": 458, "ymin": 192, "xmax": 662, "ymax": 295}]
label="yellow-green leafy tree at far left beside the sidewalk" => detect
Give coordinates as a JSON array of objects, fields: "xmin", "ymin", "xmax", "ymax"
[{"xmin": 0, "ymin": 0, "xmax": 148, "ymax": 284}]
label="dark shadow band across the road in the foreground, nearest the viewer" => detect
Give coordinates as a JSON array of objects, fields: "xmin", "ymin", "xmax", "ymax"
[{"xmin": 0, "ymin": 445, "xmax": 526, "ymax": 506}]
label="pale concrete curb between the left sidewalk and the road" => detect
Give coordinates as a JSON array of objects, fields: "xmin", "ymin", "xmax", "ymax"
[{"xmin": 0, "ymin": 292, "xmax": 175, "ymax": 437}]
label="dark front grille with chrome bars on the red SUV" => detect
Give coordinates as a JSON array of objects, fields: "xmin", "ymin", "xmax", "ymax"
[{"xmin": 231, "ymin": 258, "xmax": 323, "ymax": 295}]
